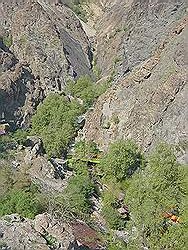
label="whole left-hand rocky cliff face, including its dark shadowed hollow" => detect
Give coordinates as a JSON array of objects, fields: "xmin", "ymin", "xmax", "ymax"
[{"xmin": 0, "ymin": 0, "xmax": 92, "ymax": 125}]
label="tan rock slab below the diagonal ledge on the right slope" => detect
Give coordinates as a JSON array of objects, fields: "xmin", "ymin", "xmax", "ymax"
[{"xmin": 84, "ymin": 6, "xmax": 188, "ymax": 159}]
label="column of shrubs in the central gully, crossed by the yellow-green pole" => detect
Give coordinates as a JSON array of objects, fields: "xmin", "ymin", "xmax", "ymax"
[{"xmin": 54, "ymin": 141, "xmax": 98, "ymax": 221}]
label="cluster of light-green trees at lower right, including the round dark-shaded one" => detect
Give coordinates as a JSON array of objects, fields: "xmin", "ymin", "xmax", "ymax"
[{"xmin": 97, "ymin": 141, "xmax": 188, "ymax": 250}]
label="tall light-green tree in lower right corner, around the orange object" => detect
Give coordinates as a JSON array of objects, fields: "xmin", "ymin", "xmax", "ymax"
[{"xmin": 126, "ymin": 144, "xmax": 186, "ymax": 250}]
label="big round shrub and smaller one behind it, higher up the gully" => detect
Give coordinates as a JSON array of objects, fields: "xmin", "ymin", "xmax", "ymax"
[{"xmin": 32, "ymin": 76, "xmax": 107, "ymax": 157}]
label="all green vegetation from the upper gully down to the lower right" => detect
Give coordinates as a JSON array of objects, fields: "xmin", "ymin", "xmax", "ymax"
[{"xmin": 0, "ymin": 77, "xmax": 188, "ymax": 250}]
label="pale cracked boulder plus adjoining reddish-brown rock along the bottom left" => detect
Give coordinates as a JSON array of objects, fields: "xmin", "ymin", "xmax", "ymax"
[{"xmin": 0, "ymin": 213, "xmax": 101, "ymax": 250}]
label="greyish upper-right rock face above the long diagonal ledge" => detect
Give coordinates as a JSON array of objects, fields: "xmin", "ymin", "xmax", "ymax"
[{"xmin": 96, "ymin": 0, "xmax": 186, "ymax": 76}]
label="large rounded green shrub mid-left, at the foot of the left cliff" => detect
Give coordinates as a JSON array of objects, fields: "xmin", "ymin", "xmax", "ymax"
[{"xmin": 32, "ymin": 94, "xmax": 83, "ymax": 157}]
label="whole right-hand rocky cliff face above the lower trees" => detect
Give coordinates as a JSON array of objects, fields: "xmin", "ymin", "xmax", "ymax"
[{"xmin": 84, "ymin": 1, "xmax": 188, "ymax": 158}]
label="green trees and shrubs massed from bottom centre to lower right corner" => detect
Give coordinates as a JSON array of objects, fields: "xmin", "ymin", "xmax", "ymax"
[{"xmin": 49, "ymin": 140, "xmax": 187, "ymax": 250}]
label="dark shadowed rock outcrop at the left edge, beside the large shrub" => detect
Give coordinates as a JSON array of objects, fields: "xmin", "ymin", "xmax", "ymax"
[{"xmin": 0, "ymin": 43, "xmax": 40, "ymax": 125}]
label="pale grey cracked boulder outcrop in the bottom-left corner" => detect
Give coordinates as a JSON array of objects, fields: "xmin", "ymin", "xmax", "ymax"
[{"xmin": 0, "ymin": 213, "xmax": 76, "ymax": 250}]
